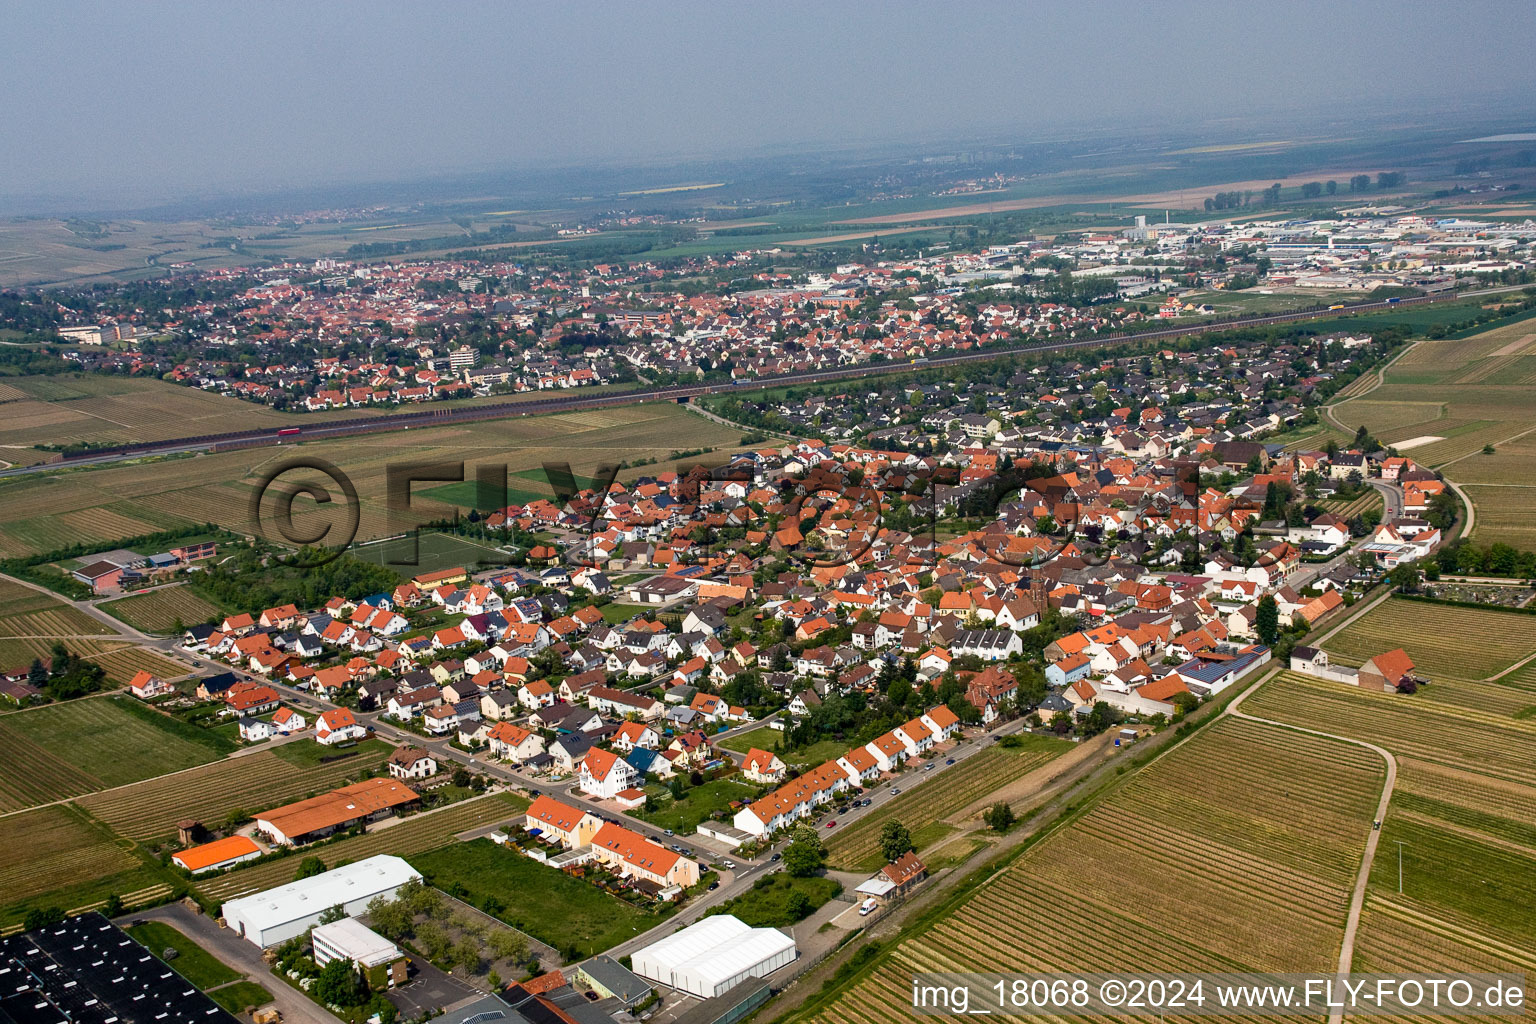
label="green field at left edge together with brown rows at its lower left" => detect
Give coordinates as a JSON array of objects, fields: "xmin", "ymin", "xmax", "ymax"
[{"xmin": 0, "ymin": 695, "xmax": 233, "ymax": 808}]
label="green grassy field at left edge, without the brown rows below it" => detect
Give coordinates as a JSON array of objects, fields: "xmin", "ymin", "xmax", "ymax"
[{"xmin": 0, "ymin": 697, "xmax": 235, "ymax": 788}]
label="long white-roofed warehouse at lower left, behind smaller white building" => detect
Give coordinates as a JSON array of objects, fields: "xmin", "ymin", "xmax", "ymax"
[{"xmin": 223, "ymin": 854, "xmax": 421, "ymax": 947}]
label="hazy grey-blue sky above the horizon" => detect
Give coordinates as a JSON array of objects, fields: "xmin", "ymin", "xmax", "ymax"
[{"xmin": 0, "ymin": 0, "xmax": 1536, "ymax": 200}]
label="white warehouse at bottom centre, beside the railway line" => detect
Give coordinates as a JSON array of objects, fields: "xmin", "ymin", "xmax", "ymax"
[{"xmin": 631, "ymin": 913, "xmax": 799, "ymax": 999}]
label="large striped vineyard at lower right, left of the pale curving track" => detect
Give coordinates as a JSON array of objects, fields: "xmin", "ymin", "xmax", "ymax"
[{"xmin": 814, "ymin": 718, "xmax": 1385, "ymax": 1024}]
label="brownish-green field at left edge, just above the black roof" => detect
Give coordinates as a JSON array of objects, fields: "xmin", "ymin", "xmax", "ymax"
[{"xmin": 0, "ymin": 804, "xmax": 160, "ymax": 927}]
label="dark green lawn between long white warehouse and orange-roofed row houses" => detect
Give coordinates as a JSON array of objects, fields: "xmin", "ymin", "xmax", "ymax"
[{"xmin": 409, "ymin": 838, "xmax": 664, "ymax": 956}]
